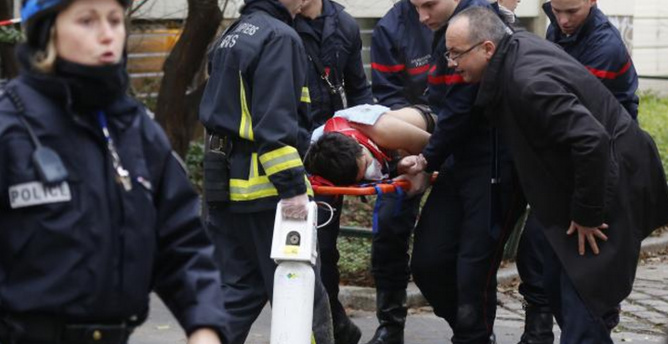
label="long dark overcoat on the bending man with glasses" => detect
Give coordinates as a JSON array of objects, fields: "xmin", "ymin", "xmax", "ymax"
[{"xmin": 476, "ymin": 32, "xmax": 668, "ymax": 314}]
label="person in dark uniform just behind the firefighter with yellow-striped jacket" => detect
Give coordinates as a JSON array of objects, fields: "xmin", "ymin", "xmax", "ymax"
[{"xmin": 295, "ymin": 0, "xmax": 373, "ymax": 344}]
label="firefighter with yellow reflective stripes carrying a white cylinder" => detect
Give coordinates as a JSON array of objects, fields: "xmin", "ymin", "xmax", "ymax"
[{"xmin": 200, "ymin": 0, "xmax": 333, "ymax": 344}]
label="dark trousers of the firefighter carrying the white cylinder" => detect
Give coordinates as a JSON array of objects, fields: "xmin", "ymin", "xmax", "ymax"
[{"xmin": 207, "ymin": 207, "xmax": 334, "ymax": 344}]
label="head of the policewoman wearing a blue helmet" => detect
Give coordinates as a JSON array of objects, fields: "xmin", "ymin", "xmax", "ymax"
[{"xmin": 21, "ymin": 0, "xmax": 130, "ymax": 72}]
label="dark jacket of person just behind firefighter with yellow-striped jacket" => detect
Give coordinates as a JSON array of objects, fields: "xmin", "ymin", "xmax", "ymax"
[{"xmin": 295, "ymin": 0, "xmax": 373, "ymax": 129}]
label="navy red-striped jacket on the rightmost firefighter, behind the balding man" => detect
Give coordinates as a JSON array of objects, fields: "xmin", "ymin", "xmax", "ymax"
[{"xmin": 543, "ymin": 2, "xmax": 639, "ymax": 118}]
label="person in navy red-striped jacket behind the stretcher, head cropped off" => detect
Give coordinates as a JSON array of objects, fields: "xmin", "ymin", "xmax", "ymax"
[{"xmin": 368, "ymin": 0, "xmax": 434, "ymax": 344}]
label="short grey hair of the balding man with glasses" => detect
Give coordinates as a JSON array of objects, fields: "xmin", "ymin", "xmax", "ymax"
[{"xmin": 448, "ymin": 7, "xmax": 511, "ymax": 45}]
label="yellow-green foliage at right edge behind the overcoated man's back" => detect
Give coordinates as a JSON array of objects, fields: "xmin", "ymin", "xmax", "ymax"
[{"xmin": 638, "ymin": 92, "xmax": 668, "ymax": 171}]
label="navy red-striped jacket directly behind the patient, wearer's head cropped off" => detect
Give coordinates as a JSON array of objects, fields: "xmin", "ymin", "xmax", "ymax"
[{"xmin": 371, "ymin": 0, "xmax": 433, "ymax": 109}]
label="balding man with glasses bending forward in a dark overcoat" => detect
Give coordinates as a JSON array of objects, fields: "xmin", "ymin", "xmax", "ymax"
[{"xmin": 438, "ymin": 9, "xmax": 668, "ymax": 344}]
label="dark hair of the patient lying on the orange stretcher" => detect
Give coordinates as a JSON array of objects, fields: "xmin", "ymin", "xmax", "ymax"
[{"xmin": 304, "ymin": 133, "xmax": 362, "ymax": 185}]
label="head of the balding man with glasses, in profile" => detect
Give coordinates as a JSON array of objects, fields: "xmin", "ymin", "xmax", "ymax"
[{"xmin": 445, "ymin": 7, "xmax": 507, "ymax": 83}]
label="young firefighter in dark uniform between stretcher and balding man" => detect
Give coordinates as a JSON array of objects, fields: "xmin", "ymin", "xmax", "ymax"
[{"xmin": 403, "ymin": 0, "xmax": 524, "ymax": 344}]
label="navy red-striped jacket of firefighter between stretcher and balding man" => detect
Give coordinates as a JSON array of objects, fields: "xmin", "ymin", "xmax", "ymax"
[{"xmin": 422, "ymin": 0, "xmax": 509, "ymax": 171}]
